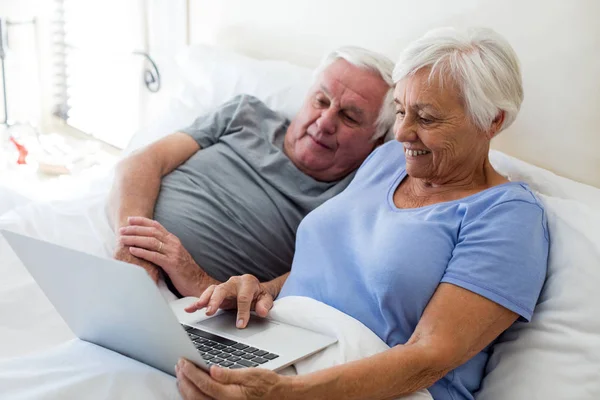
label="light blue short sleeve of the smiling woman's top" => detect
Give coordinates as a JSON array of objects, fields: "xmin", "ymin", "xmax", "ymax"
[{"xmin": 441, "ymin": 200, "xmax": 549, "ymax": 321}]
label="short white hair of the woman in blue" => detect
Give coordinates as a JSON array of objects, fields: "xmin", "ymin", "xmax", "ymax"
[{"xmin": 393, "ymin": 28, "xmax": 523, "ymax": 130}]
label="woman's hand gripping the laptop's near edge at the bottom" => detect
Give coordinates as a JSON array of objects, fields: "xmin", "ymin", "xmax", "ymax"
[{"xmin": 175, "ymin": 359, "xmax": 293, "ymax": 400}]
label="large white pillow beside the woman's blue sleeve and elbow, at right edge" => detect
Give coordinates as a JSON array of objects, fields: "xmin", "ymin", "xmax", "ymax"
[{"xmin": 476, "ymin": 195, "xmax": 600, "ymax": 400}]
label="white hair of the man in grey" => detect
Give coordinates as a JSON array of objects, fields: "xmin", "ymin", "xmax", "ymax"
[{"xmin": 314, "ymin": 46, "xmax": 396, "ymax": 140}]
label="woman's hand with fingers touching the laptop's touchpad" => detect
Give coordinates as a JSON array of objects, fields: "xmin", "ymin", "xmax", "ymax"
[{"xmin": 185, "ymin": 274, "xmax": 275, "ymax": 328}]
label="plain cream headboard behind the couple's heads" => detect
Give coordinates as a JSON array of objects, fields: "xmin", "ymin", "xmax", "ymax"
[{"xmin": 187, "ymin": 0, "xmax": 600, "ymax": 187}]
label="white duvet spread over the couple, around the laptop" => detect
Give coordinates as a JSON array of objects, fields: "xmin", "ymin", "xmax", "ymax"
[{"xmin": 0, "ymin": 190, "xmax": 432, "ymax": 400}]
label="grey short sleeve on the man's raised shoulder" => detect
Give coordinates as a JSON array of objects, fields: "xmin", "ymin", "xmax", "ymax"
[{"xmin": 180, "ymin": 96, "xmax": 244, "ymax": 149}]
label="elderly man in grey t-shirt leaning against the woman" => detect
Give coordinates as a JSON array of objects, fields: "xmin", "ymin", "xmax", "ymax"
[{"xmin": 110, "ymin": 47, "xmax": 394, "ymax": 296}]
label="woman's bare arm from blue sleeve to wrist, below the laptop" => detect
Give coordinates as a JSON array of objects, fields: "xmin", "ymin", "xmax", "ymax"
[{"xmin": 289, "ymin": 283, "xmax": 517, "ymax": 399}]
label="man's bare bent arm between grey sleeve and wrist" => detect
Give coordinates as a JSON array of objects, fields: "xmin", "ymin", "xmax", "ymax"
[{"xmin": 109, "ymin": 132, "xmax": 200, "ymax": 232}]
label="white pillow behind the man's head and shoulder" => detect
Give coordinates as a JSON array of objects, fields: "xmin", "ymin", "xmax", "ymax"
[{"xmin": 124, "ymin": 45, "xmax": 313, "ymax": 155}]
